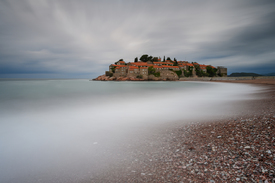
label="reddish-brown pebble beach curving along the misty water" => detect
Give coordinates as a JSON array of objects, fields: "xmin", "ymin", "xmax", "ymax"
[{"xmin": 89, "ymin": 79, "xmax": 275, "ymax": 183}]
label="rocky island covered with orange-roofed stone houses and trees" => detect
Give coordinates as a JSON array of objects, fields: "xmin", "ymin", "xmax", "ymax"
[{"xmin": 93, "ymin": 54, "xmax": 227, "ymax": 81}]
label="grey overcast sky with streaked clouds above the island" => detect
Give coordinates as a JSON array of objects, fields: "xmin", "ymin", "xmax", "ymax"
[{"xmin": 0, "ymin": 0, "xmax": 275, "ymax": 78}]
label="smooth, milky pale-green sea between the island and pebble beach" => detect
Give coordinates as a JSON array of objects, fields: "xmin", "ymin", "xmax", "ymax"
[{"xmin": 0, "ymin": 80, "xmax": 261, "ymax": 183}]
